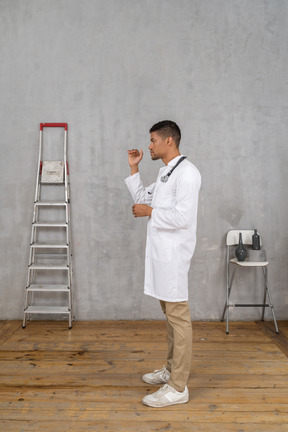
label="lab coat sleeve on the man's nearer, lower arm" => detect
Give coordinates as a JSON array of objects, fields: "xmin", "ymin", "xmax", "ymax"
[{"xmin": 151, "ymin": 170, "xmax": 201, "ymax": 230}]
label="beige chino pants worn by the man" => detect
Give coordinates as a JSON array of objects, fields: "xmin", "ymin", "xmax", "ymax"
[{"xmin": 160, "ymin": 300, "xmax": 192, "ymax": 392}]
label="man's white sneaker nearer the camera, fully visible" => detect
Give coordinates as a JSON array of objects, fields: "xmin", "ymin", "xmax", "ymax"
[{"xmin": 142, "ymin": 384, "xmax": 189, "ymax": 408}]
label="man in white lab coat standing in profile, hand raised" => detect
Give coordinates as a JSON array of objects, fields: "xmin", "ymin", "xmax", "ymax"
[{"xmin": 125, "ymin": 120, "xmax": 201, "ymax": 407}]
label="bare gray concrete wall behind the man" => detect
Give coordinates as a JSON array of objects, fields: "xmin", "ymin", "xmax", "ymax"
[{"xmin": 0, "ymin": 0, "xmax": 288, "ymax": 320}]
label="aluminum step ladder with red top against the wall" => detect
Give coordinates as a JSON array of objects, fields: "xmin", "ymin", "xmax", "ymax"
[{"xmin": 23, "ymin": 123, "xmax": 73, "ymax": 328}]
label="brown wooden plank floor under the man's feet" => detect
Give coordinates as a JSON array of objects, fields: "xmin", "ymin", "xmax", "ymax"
[{"xmin": 0, "ymin": 321, "xmax": 288, "ymax": 432}]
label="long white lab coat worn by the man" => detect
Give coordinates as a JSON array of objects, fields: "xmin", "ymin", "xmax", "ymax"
[{"xmin": 125, "ymin": 156, "xmax": 201, "ymax": 302}]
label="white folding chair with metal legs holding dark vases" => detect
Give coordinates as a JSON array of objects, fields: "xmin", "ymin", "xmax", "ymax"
[{"xmin": 222, "ymin": 230, "xmax": 279, "ymax": 334}]
